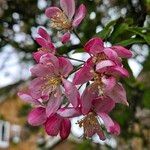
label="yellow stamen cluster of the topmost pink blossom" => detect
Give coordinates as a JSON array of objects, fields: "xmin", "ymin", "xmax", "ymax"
[{"xmin": 51, "ymin": 12, "xmax": 71, "ymax": 30}]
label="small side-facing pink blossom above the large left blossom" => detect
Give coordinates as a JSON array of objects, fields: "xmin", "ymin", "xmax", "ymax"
[{"xmin": 33, "ymin": 28, "xmax": 56, "ymax": 62}]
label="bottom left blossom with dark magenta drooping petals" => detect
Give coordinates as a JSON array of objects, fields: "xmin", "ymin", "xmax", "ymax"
[{"xmin": 28, "ymin": 106, "xmax": 80, "ymax": 140}]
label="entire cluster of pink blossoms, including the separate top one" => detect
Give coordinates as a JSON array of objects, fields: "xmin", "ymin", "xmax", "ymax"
[{"xmin": 18, "ymin": 0, "xmax": 132, "ymax": 140}]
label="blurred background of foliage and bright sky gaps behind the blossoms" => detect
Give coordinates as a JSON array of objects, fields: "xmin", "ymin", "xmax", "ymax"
[{"xmin": 0, "ymin": 0, "xmax": 150, "ymax": 150}]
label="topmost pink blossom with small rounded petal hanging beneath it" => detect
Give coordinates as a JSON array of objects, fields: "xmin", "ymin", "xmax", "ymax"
[{"xmin": 45, "ymin": 0, "xmax": 86, "ymax": 43}]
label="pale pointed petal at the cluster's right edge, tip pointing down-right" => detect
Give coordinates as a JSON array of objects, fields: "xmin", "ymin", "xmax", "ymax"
[{"xmin": 107, "ymin": 83, "xmax": 129, "ymax": 106}]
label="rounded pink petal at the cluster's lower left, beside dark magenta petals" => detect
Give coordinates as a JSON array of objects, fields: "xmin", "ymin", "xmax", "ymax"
[{"xmin": 28, "ymin": 107, "xmax": 46, "ymax": 126}]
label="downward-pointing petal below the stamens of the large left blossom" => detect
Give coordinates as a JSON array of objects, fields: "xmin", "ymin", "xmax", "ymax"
[{"xmin": 46, "ymin": 89, "xmax": 62, "ymax": 117}]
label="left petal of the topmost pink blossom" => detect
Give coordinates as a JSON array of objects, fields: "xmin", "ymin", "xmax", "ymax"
[{"xmin": 45, "ymin": 7, "xmax": 62, "ymax": 18}]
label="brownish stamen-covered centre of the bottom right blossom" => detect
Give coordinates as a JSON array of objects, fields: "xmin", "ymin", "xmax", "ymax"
[{"xmin": 77, "ymin": 112, "xmax": 101, "ymax": 137}]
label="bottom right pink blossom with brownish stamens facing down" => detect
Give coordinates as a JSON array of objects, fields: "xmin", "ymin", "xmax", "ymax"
[{"xmin": 78, "ymin": 97, "xmax": 120, "ymax": 140}]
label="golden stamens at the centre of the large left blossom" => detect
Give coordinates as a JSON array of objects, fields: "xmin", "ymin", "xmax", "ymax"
[{"xmin": 42, "ymin": 76, "xmax": 61, "ymax": 92}]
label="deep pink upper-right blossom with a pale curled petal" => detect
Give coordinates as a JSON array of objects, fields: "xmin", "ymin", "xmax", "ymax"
[{"xmin": 73, "ymin": 38, "xmax": 132, "ymax": 85}]
